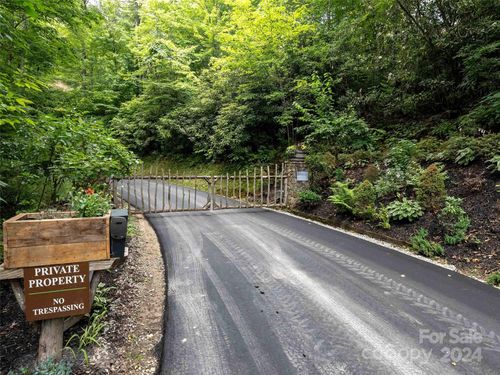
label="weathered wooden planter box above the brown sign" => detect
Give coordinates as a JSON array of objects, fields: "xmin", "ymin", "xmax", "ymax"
[{"xmin": 3, "ymin": 212, "xmax": 110, "ymax": 269}]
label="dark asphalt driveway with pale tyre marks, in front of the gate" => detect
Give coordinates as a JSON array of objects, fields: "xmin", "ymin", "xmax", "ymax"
[{"xmin": 119, "ymin": 181, "xmax": 500, "ymax": 375}]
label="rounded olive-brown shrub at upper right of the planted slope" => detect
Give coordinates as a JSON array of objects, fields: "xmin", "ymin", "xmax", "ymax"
[{"xmin": 416, "ymin": 164, "xmax": 446, "ymax": 211}]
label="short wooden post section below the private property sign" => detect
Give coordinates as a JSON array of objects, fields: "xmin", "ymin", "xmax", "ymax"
[{"xmin": 37, "ymin": 318, "xmax": 64, "ymax": 362}]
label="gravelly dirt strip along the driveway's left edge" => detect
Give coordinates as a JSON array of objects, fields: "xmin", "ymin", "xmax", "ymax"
[{"xmin": 76, "ymin": 216, "xmax": 166, "ymax": 375}]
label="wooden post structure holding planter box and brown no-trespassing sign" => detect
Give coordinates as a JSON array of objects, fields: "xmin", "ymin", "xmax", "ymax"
[{"xmin": 0, "ymin": 212, "xmax": 116, "ymax": 361}]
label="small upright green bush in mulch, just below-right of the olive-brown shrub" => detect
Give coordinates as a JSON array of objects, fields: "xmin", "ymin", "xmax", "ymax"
[{"xmin": 438, "ymin": 197, "xmax": 470, "ymax": 245}]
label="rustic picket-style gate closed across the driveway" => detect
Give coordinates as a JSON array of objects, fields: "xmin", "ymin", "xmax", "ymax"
[{"xmin": 110, "ymin": 164, "xmax": 288, "ymax": 213}]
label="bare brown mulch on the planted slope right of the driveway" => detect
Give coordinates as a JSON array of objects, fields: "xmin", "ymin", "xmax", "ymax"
[{"xmin": 295, "ymin": 163, "xmax": 500, "ymax": 278}]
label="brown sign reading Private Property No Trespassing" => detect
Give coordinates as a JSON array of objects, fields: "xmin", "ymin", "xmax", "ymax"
[{"xmin": 24, "ymin": 262, "xmax": 90, "ymax": 321}]
